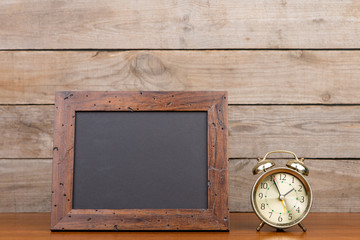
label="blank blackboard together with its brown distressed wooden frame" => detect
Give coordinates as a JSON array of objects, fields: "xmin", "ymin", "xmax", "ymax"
[{"xmin": 51, "ymin": 91, "xmax": 229, "ymax": 231}]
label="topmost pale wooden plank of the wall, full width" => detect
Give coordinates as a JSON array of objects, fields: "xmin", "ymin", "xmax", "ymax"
[{"xmin": 0, "ymin": 0, "xmax": 360, "ymax": 49}]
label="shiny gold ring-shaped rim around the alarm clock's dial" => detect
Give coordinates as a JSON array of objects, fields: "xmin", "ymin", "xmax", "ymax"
[{"xmin": 250, "ymin": 167, "xmax": 313, "ymax": 229}]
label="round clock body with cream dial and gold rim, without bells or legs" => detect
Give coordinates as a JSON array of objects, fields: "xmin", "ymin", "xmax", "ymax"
[{"xmin": 251, "ymin": 168, "xmax": 312, "ymax": 228}]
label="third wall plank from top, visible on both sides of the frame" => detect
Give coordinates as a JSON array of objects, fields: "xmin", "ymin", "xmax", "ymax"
[{"xmin": 0, "ymin": 105, "xmax": 360, "ymax": 158}]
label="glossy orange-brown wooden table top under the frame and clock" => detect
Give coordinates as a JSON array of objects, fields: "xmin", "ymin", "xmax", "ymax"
[{"xmin": 0, "ymin": 213, "xmax": 360, "ymax": 240}]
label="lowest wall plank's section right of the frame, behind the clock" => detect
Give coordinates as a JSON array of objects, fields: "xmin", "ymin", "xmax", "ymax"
[{"xmin": 229, "ymin": 159, "xmax": 360, "ymax": 212}]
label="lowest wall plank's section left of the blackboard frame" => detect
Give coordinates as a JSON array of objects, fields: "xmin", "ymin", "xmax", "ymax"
[{"xmin": 0, "ymin": 159, "xmax": 52, "ymax": 212}]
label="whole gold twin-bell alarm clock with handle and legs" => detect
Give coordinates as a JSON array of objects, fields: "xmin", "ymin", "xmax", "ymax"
[{"xmin": 251, "ymin": 150, "xmax": 313, "ymax": 232}]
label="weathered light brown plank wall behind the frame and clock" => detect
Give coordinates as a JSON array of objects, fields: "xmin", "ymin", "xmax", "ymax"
[{"xmin": 0, "ymin": 0, "xmax": 360, "ymax": 212}]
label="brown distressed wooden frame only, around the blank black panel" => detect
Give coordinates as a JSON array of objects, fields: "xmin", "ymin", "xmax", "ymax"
[{"xmin": 51, "ymin": 92, "xmax": 229, "ymax": 231}]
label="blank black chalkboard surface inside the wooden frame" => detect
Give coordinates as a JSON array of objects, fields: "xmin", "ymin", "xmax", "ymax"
[{"xmin": 73, "ymin": 111, "xmax": 208, "ymax": 209}]
